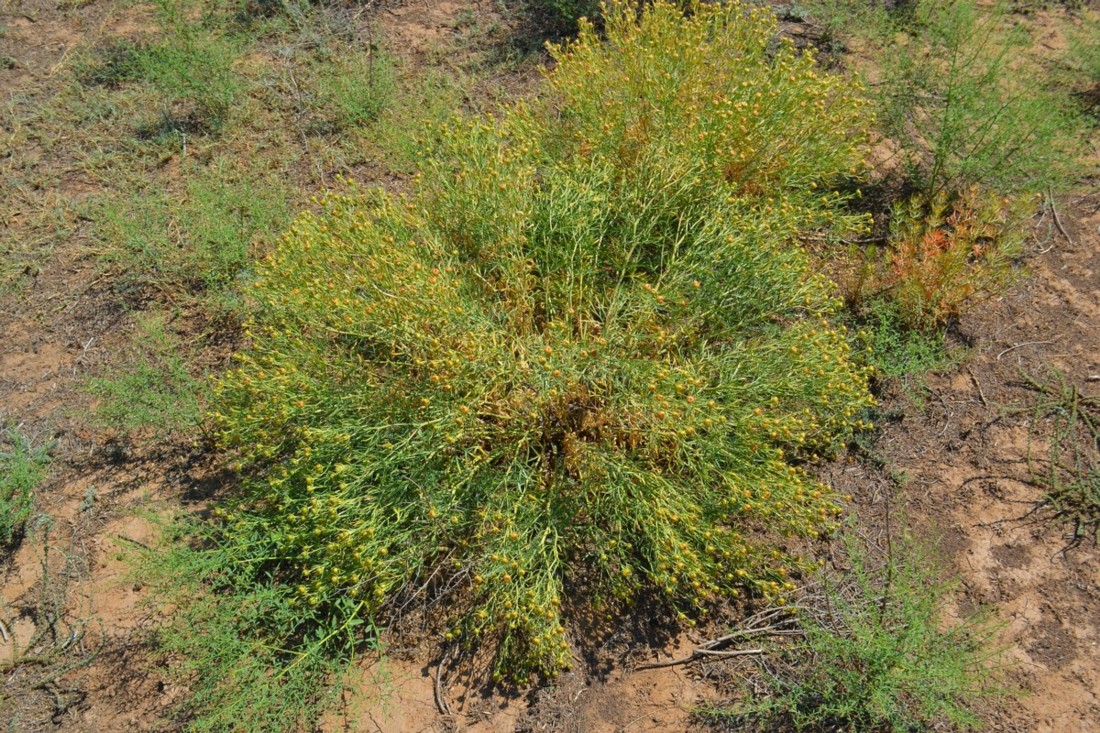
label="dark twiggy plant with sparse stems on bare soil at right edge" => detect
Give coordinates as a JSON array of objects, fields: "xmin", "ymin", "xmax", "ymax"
[{"xmin": 1025, "ymin": 370, "xmax": 1100, "ymax": 546}]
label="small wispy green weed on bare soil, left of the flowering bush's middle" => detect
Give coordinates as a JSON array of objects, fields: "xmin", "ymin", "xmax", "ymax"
[{"xmin": 88, "ymin": 315, "xmax": 204, "ymax": 433}]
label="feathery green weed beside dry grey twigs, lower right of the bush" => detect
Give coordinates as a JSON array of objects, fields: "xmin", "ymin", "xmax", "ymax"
[{"xmin": 712, "ymin": 532, "xmax": 1004, "ymax": 733}]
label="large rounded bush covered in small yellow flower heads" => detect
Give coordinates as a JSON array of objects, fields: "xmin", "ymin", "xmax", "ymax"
[{"xmin": 215, "ymin": 3, "xmax": 870, "ymax": 679}]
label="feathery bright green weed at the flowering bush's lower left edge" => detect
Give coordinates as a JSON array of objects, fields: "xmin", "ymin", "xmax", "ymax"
[{"xmin": 134, "ymin": 512, "xmax": 366, "ymax": 733}]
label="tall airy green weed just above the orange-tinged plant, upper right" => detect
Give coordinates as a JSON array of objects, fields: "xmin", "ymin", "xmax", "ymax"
[{"xmin": 879, "ymin": 0, "xmax": 1082, "ymax": 203}]
